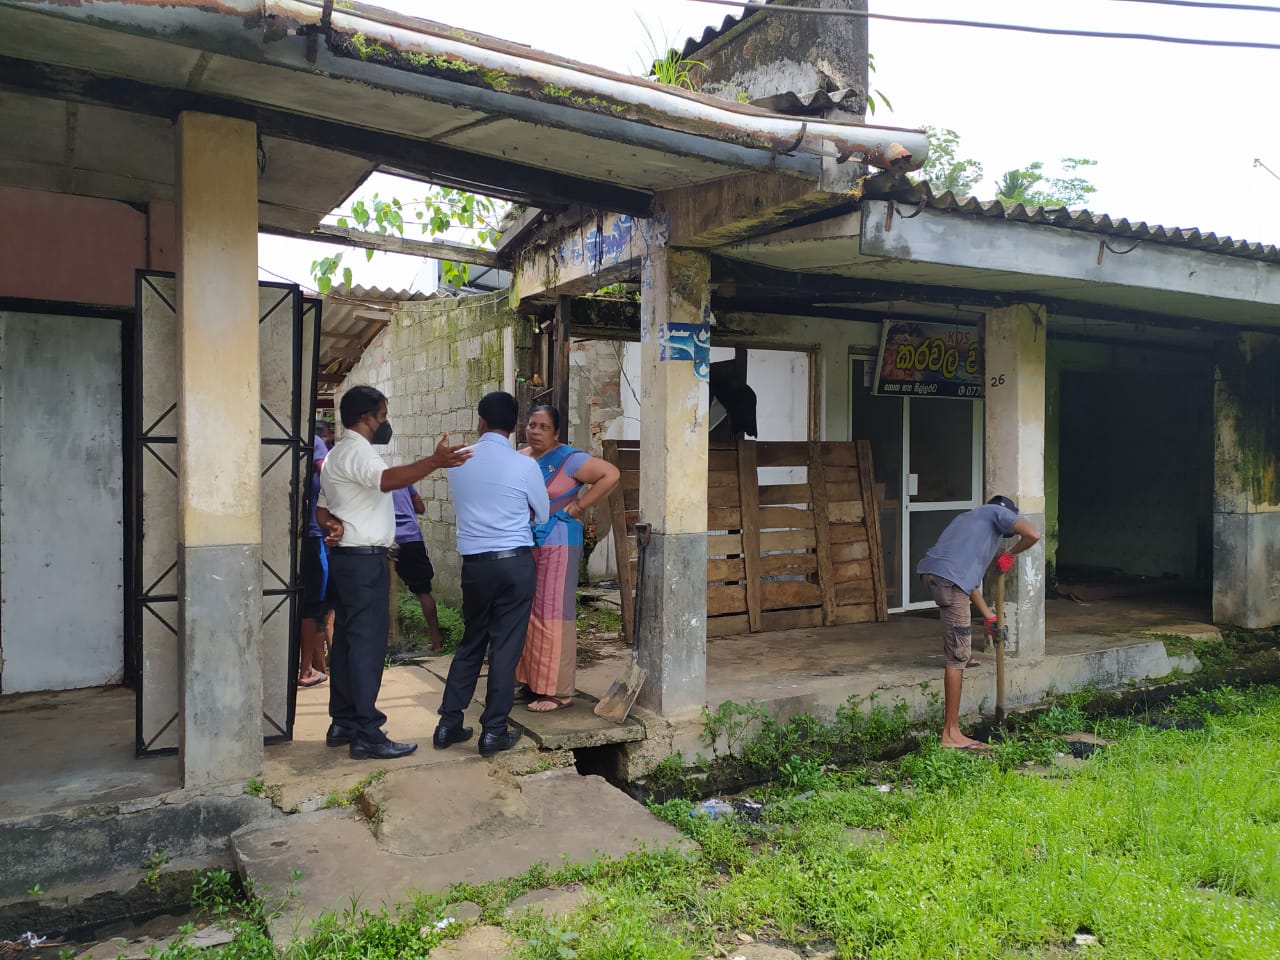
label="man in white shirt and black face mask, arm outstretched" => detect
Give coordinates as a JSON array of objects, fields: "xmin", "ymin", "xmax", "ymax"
[{"xmin": 316, "ymin": 387, "xmax": 471, "ymax": 760}]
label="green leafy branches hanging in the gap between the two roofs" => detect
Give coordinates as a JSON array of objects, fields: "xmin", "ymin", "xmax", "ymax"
[{"xmin": 311, "ymin": 187, "xmax": 507, "ymax": 293}]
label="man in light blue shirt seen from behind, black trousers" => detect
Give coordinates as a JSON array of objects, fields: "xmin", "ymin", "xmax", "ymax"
[{"xmin": 433, "ymin": 390, "xmax": 550, "ymax": 756}]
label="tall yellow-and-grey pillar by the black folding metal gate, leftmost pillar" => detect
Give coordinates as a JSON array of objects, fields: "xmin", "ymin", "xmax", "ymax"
[{"xmin": 177, "ymin": 113, "xmax": 262, "ymax": 787}]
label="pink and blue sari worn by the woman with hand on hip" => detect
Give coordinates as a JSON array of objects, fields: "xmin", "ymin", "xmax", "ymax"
[{"xmin": 516, "ymin": 444, "xmax": 590, "ymax": 698}]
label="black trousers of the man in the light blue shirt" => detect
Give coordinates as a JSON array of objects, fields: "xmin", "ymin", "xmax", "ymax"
[{"xmin": 440, "ymin": 550, "xmax": 538, "ymax": 733}]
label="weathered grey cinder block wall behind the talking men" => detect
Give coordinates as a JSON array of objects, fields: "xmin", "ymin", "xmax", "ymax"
[{"xmin": 339, "ymin": 292, "xmax": 530, "ymax": 607}]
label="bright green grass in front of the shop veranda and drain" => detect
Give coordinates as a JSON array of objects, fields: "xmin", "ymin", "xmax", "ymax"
[{"xmin": 145, "ymin": 687, "xmax": 1280, "ymax": 960}]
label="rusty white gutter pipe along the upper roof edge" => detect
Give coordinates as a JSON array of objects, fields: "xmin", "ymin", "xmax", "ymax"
[{"xmin": 270, "ymin": 0, "xmax": 928, "ymax": 172}]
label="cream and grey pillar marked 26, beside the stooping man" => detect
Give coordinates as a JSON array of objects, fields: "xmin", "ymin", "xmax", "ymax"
[{"xmin": 983, "ymin": 303, "xmax": 1046, "ymax": 657}]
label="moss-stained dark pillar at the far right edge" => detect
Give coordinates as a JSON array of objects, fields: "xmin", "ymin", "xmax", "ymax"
[{"xmin": 1213, "ymin": 333, "xmax": 1280, "ymax": 627}]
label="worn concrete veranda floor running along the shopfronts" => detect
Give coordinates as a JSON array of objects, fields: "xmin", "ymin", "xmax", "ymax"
[{"xmin": 0, "ymin": 596, "xmax": 1213, "ymax": 819}]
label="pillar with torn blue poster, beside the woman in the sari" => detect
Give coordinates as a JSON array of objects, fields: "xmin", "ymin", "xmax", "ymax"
[{"xmin": 639, "ymin": 246, "xmax": 710, "ymax": 717}]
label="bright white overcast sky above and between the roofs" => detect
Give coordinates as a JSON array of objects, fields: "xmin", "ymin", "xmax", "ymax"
[{"xmin": 260, "ymin": 0, "xmax": 1280, "ymax": 293}]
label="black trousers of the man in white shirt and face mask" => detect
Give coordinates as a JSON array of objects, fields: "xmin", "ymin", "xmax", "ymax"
[{"xmin": 328, "ymin": 549, "xmax": 390, "ymax": 744}]
